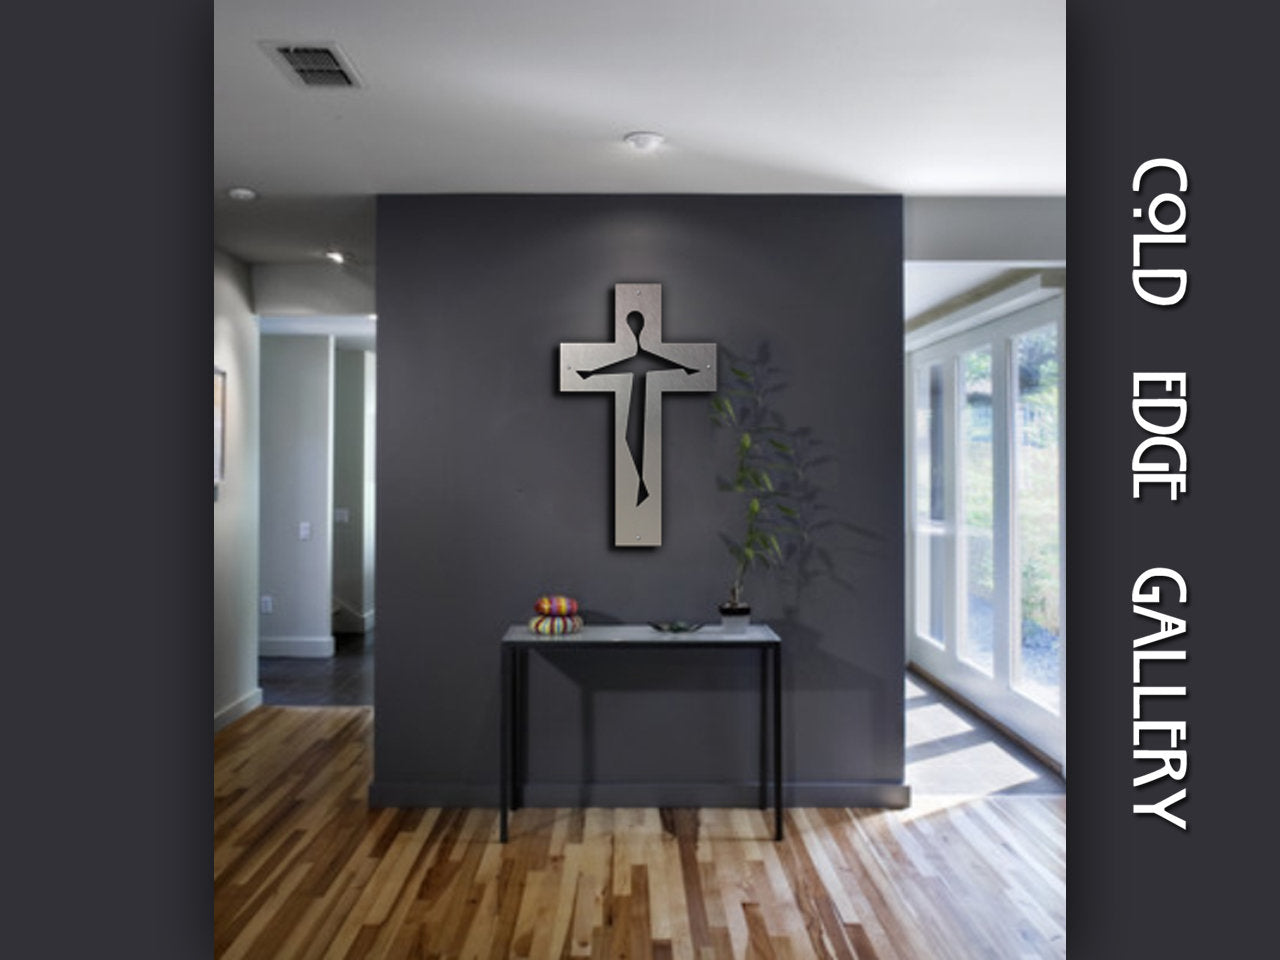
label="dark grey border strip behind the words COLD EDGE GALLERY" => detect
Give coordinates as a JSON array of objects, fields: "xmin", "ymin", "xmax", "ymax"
[{"xmin": 1066, "ymin": 0, "xmax": 1280, "ymax": 960}]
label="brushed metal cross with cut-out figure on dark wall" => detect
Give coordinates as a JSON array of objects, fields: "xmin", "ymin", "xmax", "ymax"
[{"xmin": 559, "ymin": 283, "xmax": 716, "ymax": 547}]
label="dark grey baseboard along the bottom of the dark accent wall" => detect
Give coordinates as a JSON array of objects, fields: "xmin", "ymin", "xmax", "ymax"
[{"xmin": 369, "ymin": 781, "xmax": 911, "ymax": 810}]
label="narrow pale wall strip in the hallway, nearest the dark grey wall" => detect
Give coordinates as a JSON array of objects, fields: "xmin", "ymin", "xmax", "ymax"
[{"xmin": 333, "ymin": 349, "xmax": 375, "ymax": 634}]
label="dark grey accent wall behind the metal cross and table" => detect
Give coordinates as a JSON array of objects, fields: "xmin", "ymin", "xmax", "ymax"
[{"xmin": 371, "ymin": 196, "xmax": 906, "ymax": 805}]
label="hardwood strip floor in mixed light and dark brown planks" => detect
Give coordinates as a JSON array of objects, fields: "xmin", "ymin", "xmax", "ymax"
[{"xmin": 214, "ymin": 707, "xmax": 1066, "ymax": 960}]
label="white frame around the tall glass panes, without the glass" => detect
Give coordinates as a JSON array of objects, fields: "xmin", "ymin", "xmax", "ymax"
[{"xmin": 904, "ymin": 293, "xmax": 1066, "ymax": 771}]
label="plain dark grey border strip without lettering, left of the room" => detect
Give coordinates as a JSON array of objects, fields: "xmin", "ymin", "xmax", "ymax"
[{"xmin": 12, "ymin": 0, "xmax": 212, "ymax": 960}]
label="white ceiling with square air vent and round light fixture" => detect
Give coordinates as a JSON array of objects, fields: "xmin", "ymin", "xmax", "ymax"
[{"xmin": 214, "ymin": 0, "xmax": 1066, "ymax": 262}]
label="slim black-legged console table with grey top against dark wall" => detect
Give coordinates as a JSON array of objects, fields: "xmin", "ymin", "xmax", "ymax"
[{"xmin": 498, "ymin": 623, "xmax": 782, "ymax": 844}]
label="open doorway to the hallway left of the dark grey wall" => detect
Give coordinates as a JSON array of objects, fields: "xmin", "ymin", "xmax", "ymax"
[{"xmin": 259, "ymin": 317, "xmax": 376, "ymax": 705}]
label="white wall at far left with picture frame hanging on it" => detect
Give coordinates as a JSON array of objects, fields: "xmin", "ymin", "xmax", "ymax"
[{"xmin": 214, "ymin": 250, "xmax": 262, "ymax": 731}]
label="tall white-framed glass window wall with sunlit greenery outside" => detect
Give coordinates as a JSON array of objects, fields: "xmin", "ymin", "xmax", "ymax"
[{"xmin": 906, "ymin": 296, "xmax": 1066, "ymax": 762}]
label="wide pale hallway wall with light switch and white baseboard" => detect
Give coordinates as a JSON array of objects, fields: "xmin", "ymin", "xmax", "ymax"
[{"xmin": 259, "ymin": 335, "xmax": 334, "ymax": 657}]
